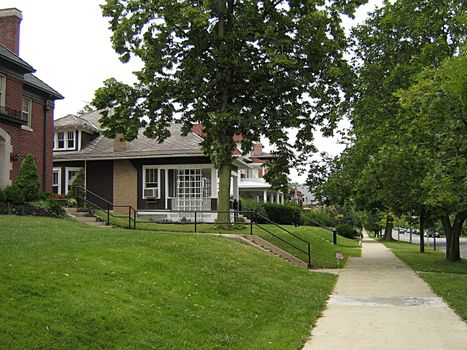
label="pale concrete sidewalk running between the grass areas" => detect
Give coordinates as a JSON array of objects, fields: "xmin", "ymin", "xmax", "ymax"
[{"xmin": 303, "ymin": 237, "xmax": 467, "ymax": 350}]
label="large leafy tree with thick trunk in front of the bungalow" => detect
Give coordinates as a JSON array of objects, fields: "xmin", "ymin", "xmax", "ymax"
[{"xmin": 93, "ymin": 0, "xmax": 365, "ymax": 221}]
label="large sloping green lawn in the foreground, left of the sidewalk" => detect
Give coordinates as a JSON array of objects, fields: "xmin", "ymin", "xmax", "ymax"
[{"xmin": 0, "ymin": 216, "xmax": 336, "ymax": 349}]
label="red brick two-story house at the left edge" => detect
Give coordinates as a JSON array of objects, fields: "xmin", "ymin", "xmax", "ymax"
[{"xmin": 0, "ymin": 8, "xmax": 63, "ymax": 191}]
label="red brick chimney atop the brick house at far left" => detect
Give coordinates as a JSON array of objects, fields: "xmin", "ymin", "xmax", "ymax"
[{"xmin": 0, "ymin": 8, "xmax": 23, "ymax": 56}]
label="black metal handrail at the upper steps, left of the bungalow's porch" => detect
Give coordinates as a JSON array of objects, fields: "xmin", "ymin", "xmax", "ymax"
[{"xmin": 73, "ymin": 186, "xmax": 137, "ymax": 229}]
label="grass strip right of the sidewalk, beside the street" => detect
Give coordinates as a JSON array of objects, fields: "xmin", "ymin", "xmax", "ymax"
[{"xmin": 384, "ymin": 242, "xmax": 467, "ymax": 321}]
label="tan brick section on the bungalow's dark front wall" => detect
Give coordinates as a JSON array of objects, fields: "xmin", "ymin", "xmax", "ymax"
[{"xmin": 113, "ymin": 160, "xmax": 138, "ymax": 210}]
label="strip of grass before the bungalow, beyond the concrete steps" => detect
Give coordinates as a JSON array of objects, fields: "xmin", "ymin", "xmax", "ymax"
[{"xmin": 98, "ymin": 212, "xmax": 361, "ymax": 269}]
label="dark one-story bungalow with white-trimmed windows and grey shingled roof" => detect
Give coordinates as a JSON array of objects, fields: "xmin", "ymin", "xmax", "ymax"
[{"xmin": 53, "ymin": 111, "xmax": 284, "ymax": 218}]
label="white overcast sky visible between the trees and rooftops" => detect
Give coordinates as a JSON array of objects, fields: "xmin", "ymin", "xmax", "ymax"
[{"xmin": 0, "ymin": 0, "xmax": 381, "ymax": 182}]
